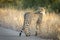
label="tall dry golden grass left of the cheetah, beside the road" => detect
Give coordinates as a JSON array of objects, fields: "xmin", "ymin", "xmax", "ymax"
[{"xmin": 0, "ymin": 8, "xmax": 33, "ymax": 30}]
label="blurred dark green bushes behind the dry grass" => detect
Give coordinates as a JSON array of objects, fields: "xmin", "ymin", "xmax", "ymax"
[{"xmin": 0, "ymin": 0, "xmax": 60, "ymax": 12}]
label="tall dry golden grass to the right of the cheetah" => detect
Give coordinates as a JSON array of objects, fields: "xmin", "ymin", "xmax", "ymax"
[{"xmin": 39, "ymin": 12, "xmax": 60, "ymax": 38}]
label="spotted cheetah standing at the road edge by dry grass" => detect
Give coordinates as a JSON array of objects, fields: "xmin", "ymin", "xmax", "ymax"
[{"xmin": 19, "ymin": 8, "xmax": 45, "ymax": 36}]
